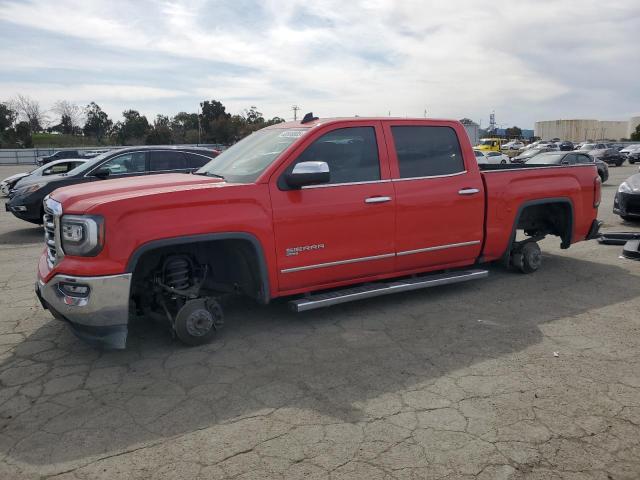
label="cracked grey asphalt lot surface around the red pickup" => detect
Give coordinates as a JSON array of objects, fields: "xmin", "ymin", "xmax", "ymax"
[{"xmin": 0, "ymin": 165, "xmax": 640, "ymax": 479}]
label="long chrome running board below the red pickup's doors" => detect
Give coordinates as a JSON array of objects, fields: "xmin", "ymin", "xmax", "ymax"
[{"xmin": 289, "ymin": 269, "xmax": 489, "ymax": 312}]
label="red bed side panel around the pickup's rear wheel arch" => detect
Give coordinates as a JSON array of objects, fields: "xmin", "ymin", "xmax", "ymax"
[{"xmin": 481, "ymin": 165, "xmax": 598, "ymax": 261}]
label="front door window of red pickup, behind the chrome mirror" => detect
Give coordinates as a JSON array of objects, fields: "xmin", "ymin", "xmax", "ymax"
[{"xmin": 290, "ymin": 127, "xmax": 380, "ymax": 184}]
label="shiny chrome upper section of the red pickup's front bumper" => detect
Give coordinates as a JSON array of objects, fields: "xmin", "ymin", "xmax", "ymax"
[{"xmin": 36, "ymin": 273, "xmax": 132, "ymax": 327}]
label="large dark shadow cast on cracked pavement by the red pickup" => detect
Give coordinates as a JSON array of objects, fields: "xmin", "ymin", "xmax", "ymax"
[{"xmin": 0, "ymin": 254, "xmax": 640, "ymax": 472}]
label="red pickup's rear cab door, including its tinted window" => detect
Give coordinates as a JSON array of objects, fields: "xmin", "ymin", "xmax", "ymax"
[{"xmin": 384, "ymin": 120, "xmax": 484, "ymax": 271}]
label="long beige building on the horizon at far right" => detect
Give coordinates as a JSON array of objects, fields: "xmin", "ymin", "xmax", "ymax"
[{"xmin": 535, "ymin": 117, "xmax": 640, "ymax": 142}]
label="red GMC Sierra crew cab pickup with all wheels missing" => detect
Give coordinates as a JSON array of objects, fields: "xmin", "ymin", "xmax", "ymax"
[{"xmin": 36, "ymin": 115, "xmax": 601, "ymax": 348}]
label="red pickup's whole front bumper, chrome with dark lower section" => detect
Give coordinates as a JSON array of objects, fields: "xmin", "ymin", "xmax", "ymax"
[{"xmin": 36, "ymin": 273, "xmax": 131, "ymax": 348}]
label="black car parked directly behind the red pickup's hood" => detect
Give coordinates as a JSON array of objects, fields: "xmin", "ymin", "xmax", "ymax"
[{"xmin": 5, "ymin": 146, "xmax": 219, "ymax": 224}]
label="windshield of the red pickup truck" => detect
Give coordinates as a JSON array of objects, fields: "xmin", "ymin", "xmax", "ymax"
[{"xmin": 196, "ymin": 128, "xmax": 308, "ymax": 183}]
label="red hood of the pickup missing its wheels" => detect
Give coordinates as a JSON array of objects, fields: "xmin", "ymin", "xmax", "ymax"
[{"xmin": 51, "ymin": 173, "xmax": 228, "ymax": 213}]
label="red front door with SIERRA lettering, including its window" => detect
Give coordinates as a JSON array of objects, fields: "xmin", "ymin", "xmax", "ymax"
[{"xmin": 269, "ymin": 122, "xmax": 395, "ymax": 291}]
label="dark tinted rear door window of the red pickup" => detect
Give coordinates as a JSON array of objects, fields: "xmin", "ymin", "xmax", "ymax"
[{"xmin": 391, "ymin": 126, "xmax": 464, "ymax": 178}]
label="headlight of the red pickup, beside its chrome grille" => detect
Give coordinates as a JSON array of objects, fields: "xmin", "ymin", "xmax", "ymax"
[{"xmin": 60, "ymin": 215, "xmax": 104, "ymax": 257}]
